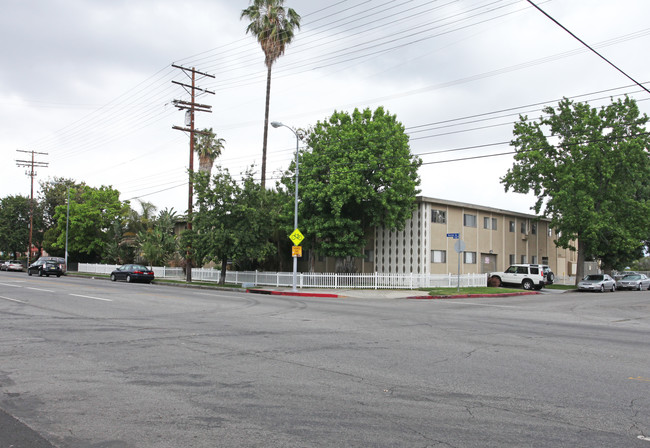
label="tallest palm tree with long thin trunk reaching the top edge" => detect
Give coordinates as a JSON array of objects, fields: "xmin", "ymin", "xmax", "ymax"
[{"xmin": 240, "ymin": 0, "xmax": 300, "ymax": 188}]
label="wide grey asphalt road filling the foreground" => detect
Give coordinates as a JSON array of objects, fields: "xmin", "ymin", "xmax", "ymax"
[{"xmin": 0, "ymin": 272, "xmax": 650, "ymax": 448}]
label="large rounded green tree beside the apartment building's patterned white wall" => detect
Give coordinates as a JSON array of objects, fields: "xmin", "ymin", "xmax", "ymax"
[{"xmin": 283, "ymin": 107, "xmax": 422, "ymax": 272}]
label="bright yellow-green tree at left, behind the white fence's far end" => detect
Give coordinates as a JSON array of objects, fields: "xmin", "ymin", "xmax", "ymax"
[{"xmin": 46, "ymin": 186, "xmax": 130, "ymax": 262}]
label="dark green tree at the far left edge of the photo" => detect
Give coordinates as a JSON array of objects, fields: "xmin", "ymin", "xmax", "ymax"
[{"xmin": 0, "ymin": 195, "xmax": 30, "ymax": 259}]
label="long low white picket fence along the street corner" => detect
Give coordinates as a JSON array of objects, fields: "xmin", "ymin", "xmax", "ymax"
[{"xmin": 78, "ymin": 263, "xmax": 487, "ymax": 289}]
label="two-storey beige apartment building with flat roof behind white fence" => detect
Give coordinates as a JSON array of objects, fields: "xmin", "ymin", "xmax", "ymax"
[{"xmin": 301, "ymin": 196, "xmax": 578, "ymax": 277}]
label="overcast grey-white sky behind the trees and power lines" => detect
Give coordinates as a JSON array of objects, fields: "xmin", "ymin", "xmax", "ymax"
[{"xmin": 0, "ymin": 0, "xmax": 650, "ymax": 217}]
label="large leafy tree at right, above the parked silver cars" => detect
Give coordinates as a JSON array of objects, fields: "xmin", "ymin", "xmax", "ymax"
[{"xmin": 501, "ymin": 97, "xmax": 650, "ymax": 281}]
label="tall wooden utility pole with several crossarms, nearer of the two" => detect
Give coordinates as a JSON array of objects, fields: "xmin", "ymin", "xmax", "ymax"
[{"xmin": 172, "ymin": 64, "xmax": 214, "ymax": 282}]
